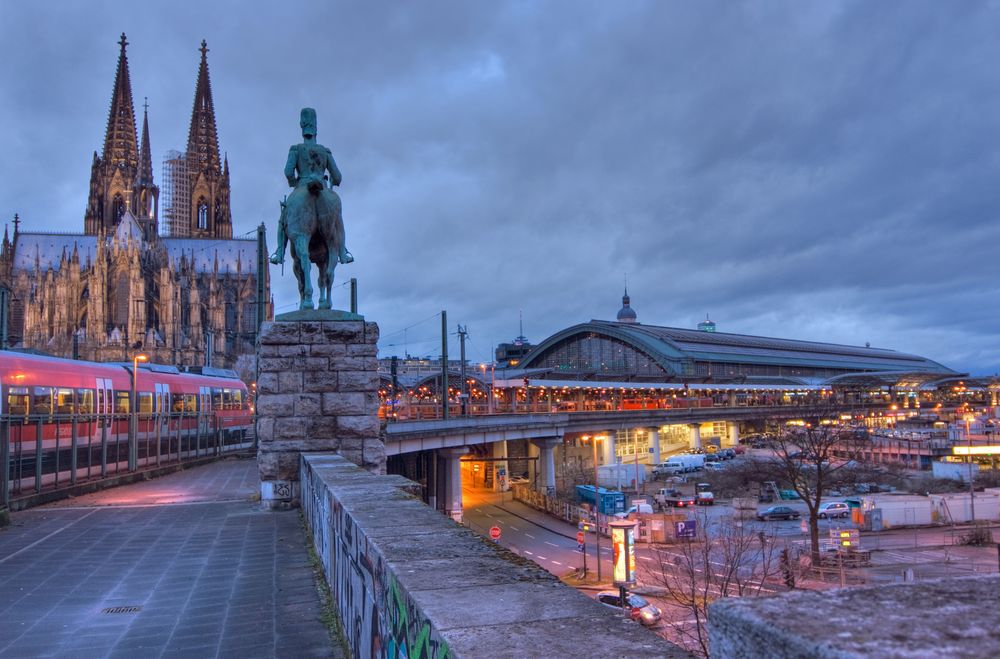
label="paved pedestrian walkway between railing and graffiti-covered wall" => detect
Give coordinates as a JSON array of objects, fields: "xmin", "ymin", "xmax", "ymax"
[{"xmin": 0, "ymin": 459, "xmax": 344, "ymax": 659}]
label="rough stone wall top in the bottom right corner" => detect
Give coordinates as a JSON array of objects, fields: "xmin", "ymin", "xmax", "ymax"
[{"xmin": 709, "ymin": 576, "xmax": 1000, "ymax": 659}]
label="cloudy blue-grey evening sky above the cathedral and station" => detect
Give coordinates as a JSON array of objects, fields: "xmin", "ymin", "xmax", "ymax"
[{"xmin": 0, "ymin": 0, "xmax": 1000, "ymax": 373}]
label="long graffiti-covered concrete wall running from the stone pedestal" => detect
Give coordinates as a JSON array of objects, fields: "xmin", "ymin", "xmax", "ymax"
[{"xmin": 301, "ymin": 453, "xmax": 688, "ymax": 657}]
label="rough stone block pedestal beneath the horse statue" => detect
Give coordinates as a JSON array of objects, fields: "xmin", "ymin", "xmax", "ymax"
[{"xmin": 256, "ymin": 311, "xmax": 385, "ymax": 508}]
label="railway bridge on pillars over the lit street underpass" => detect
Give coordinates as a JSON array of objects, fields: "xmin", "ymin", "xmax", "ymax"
[{"xmin": 386, "ymin": 403, "xmax": 886, "ymax": 519}]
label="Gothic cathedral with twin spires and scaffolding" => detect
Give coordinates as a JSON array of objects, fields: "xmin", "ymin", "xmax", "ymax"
[{"xmin": 0, "ymin": 34, "xmax": 272, "ymax": 370}]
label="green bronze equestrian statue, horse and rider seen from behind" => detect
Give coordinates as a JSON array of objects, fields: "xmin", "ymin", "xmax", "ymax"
[{"xmin": 271, "ymin": 108, "xmax": 354, "ymax": 309}]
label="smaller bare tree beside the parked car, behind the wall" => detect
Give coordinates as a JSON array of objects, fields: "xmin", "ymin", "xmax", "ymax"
[{"xmin": 653, "ymin": 514, "xmax": 780, "ymax": 657}]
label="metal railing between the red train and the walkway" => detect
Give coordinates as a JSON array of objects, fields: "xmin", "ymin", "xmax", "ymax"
[{"xmin": 0, "ymin": 412, "xmax": 254, "ymax": 507}]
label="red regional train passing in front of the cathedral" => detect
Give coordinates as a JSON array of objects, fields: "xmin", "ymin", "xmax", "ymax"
[{"xmin": 0, "ymin": 350, "xmax": 253, "ymax": 485}]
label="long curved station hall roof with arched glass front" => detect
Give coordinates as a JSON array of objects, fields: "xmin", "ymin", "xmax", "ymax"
[{"xmin": 518, "ymin": 319, "xmax": 963, "ymax": 387}]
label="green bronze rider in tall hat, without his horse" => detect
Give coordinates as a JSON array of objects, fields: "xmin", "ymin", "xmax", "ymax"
[{"xmin": 271, "ymin": 108, "xmax": 354, "ymax": 263}]
